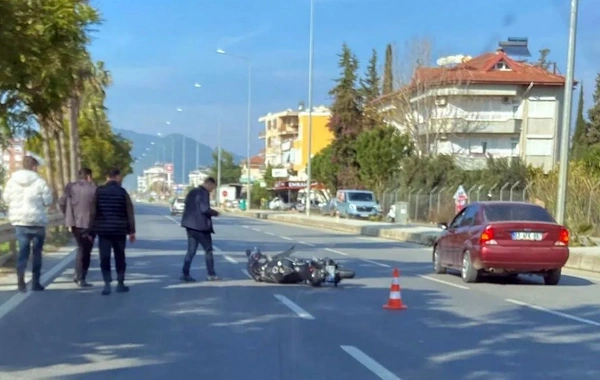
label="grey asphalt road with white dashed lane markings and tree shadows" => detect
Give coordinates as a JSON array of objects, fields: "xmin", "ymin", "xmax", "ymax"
[{"xmin": 0, "ymin": 204, "xmax": 600, "ymax": 380}]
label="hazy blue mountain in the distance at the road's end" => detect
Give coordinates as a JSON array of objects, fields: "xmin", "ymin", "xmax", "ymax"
[{"xmin": 113, "ymin": 128, "xmax": 244, "ymax": 189}]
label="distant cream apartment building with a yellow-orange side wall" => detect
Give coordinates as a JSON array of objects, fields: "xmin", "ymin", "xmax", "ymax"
[{"xmin": 258, "ymin": 106, "xmax": 333, "ymax": 179}]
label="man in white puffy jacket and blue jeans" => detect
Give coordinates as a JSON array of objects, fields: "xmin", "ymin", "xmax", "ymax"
[{"xmin": 2, "ymin": 156, "xmax": 52, "ymax": 292}]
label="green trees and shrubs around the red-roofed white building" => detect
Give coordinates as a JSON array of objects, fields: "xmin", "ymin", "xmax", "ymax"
[{"xmin": 312, "ymin": 40, "xmax": 600, "ymax": 235}]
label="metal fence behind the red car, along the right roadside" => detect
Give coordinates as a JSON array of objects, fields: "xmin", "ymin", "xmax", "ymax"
[{"xmin": 381, "ymin": 182, "xmax": 600, "ymax": 233}]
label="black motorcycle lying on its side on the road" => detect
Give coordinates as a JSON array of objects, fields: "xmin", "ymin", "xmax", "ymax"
[{"xmin": 246, "ymin": 246, "xmax": 355, "ymax": 287}]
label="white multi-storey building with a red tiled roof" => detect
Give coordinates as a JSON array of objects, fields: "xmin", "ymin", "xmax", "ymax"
[{"xmin": 377, "ymin": 49, "xmax": 565, "ymax": 170}]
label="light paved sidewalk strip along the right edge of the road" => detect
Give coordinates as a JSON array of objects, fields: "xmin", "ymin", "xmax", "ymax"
[{"xmin": 223, "ymin": 209, "xmax": 600, "ymax": 273}]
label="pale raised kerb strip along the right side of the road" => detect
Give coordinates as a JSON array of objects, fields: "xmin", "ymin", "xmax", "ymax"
[{"xmin": 221, "ymin": 209, "xmax": 600, "ymax": 273}]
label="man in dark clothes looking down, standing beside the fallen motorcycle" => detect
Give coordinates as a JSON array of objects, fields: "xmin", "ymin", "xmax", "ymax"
[{"xmin": 181, "ymin": 177, "xmax": 219, "ymax": 282}]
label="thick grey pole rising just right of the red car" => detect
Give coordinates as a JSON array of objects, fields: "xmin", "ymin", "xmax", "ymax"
[{"xmin": 556, "ymin": 0, "xmax": 579, "ymax": 224}]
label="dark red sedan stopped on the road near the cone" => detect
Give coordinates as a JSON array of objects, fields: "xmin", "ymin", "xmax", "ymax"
[{"xmin": 432, "ymin": 202, "xmax": 569, "ymax": 285}]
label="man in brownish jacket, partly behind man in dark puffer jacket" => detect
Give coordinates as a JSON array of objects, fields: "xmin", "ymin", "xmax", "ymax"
[{"xmin": 58, "ymin": 168, "xmax": 96, "ymax": 288}]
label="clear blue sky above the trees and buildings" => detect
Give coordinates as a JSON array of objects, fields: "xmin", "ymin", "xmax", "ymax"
[{"xmin": 92, "ymin": 0, "xmax": 600, "ymax": 154}]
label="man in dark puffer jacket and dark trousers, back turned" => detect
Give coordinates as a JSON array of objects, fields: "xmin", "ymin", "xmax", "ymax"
[{"xmin": 90, "ymin": 169, "xmax": 135, "ymax": 295}]
